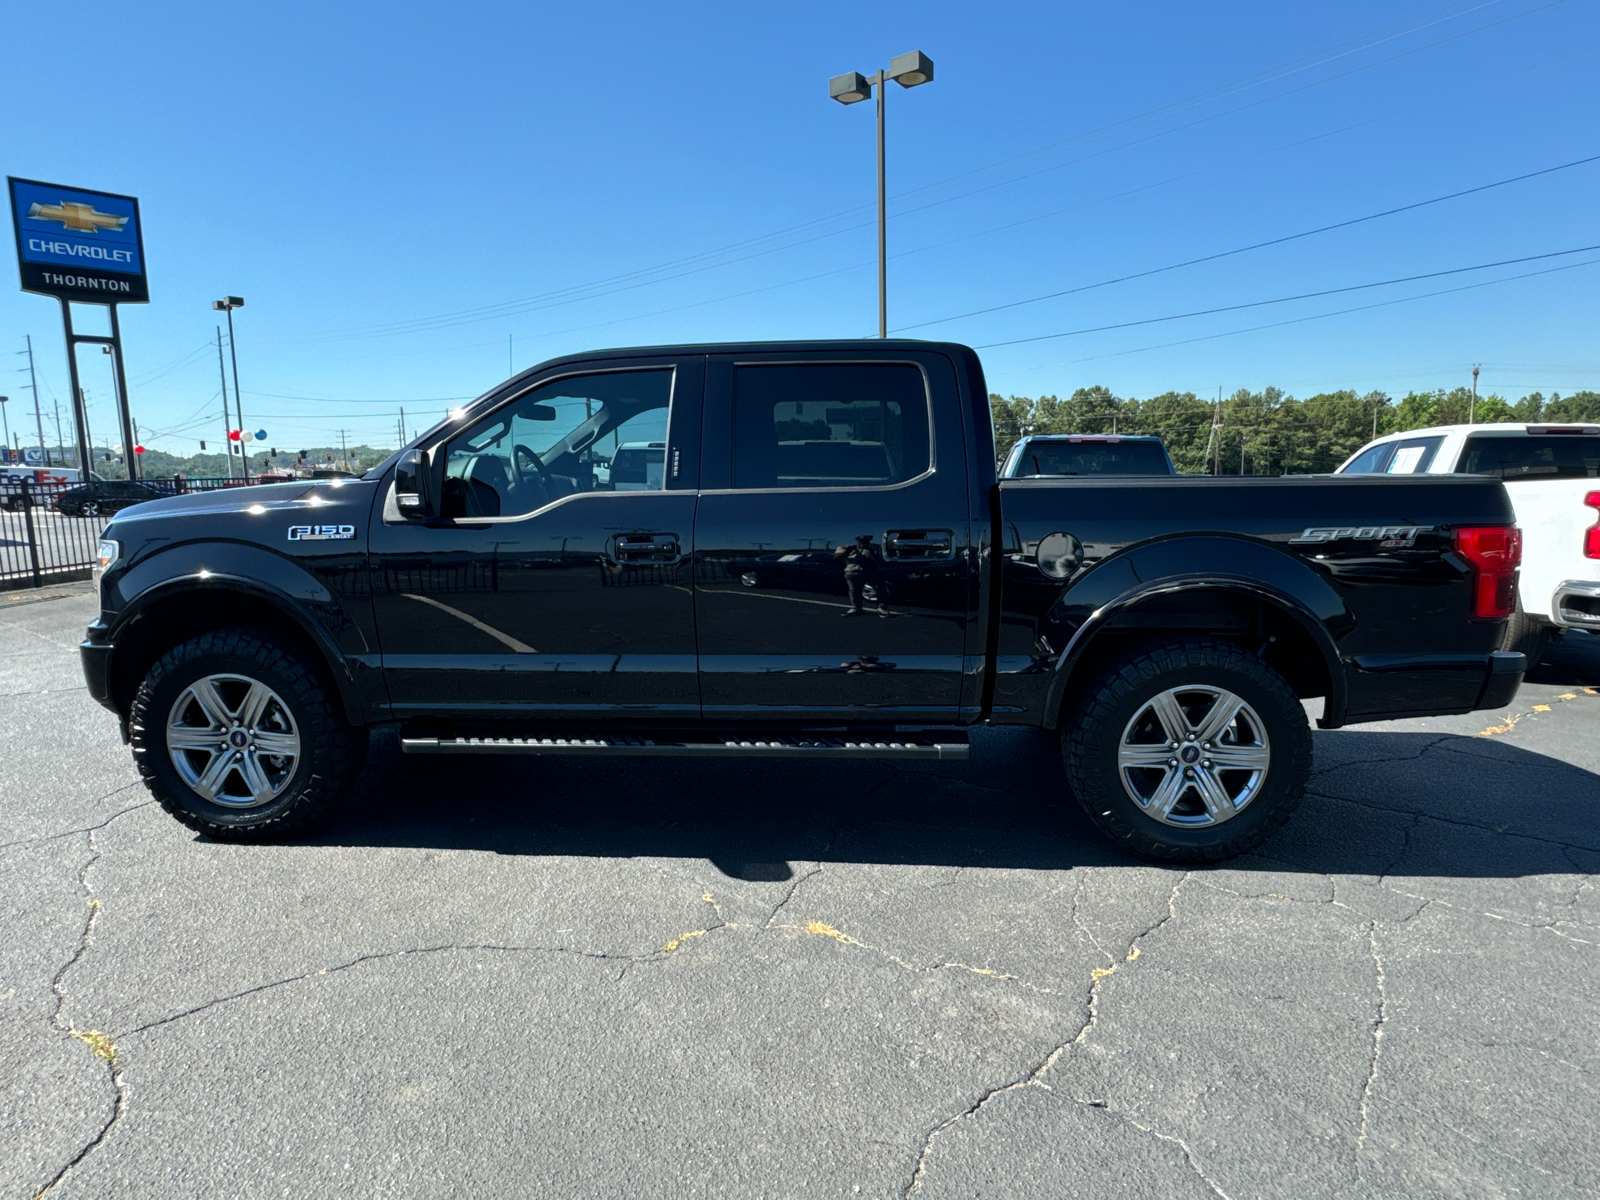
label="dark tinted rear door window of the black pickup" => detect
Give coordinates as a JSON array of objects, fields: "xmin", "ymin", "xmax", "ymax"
[{"xmin": 733, "ymin": 363, "xmax": 931, "ymax": 488}]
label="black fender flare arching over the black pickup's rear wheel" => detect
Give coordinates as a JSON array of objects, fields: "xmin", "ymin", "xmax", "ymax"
[{"xmin": 1045, "ymin": 534, "xmax": 1355, "ymax": 728}]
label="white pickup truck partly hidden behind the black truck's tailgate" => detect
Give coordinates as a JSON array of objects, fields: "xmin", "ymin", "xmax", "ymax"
[{"xmin": 1339, "ymin": 424, "xmax": 1600, "ymax": 667}]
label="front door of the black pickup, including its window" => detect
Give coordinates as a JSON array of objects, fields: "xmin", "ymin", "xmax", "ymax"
[{"xmin": 371, "ymin": 355, "xmax": 706, "ymax": 720}]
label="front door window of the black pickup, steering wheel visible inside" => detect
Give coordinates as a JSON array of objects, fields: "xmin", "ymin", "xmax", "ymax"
[{"xmin": 443, "ymin": 370, "xmax": 672, "ymax": 518}]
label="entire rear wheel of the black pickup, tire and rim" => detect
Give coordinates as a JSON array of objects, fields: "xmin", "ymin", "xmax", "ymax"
[{"xmin": 1062, "ymin": 638, "xmax": 1312, "ymax": 864}]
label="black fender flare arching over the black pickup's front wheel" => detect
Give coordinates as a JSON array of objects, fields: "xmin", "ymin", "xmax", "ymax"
[{"xmin": 107, "ymin": 546, "xmax": 366, "ymax": 725}]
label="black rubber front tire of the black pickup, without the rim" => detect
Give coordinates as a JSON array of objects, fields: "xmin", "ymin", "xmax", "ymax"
[{"xmin": 128, "ymin": 626, "xmax": 366, "ymax": 842}]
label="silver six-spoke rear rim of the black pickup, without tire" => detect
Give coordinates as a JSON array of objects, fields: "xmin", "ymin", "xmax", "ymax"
[{"xmin": 1117, "ymin": 685, "xmax": 1272, "ymax": 827}]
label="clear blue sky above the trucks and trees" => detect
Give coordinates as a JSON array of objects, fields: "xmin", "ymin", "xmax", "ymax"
[{"xmin": 0, "ymin": 0, "xmax": 1600, "ymax": 453}]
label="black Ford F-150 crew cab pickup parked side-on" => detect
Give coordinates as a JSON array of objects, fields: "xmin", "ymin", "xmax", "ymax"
[{"xmin": 82, "ymin": 341, "xmax": 1523, "ymax": 862}]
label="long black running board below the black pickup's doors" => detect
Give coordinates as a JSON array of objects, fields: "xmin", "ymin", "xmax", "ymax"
[{"xmin": 400, "ymin": 733, "xmax": 971, "ymax": 762}]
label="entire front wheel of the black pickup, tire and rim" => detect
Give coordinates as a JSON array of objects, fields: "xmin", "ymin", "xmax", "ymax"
[{"xmin": 130, "ymin": 629, "xmax": 366, "ymax": 842}]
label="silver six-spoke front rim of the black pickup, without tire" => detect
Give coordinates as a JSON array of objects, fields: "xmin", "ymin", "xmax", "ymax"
[{"xmin": 166, "ymin": 675, "xmax": 301, "ymax": 808}]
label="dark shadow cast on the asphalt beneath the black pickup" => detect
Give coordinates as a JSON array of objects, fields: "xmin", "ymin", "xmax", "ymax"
[{"xmin": 310, "ymin": 730, "xmax": 1600, "ymax": 880}]
